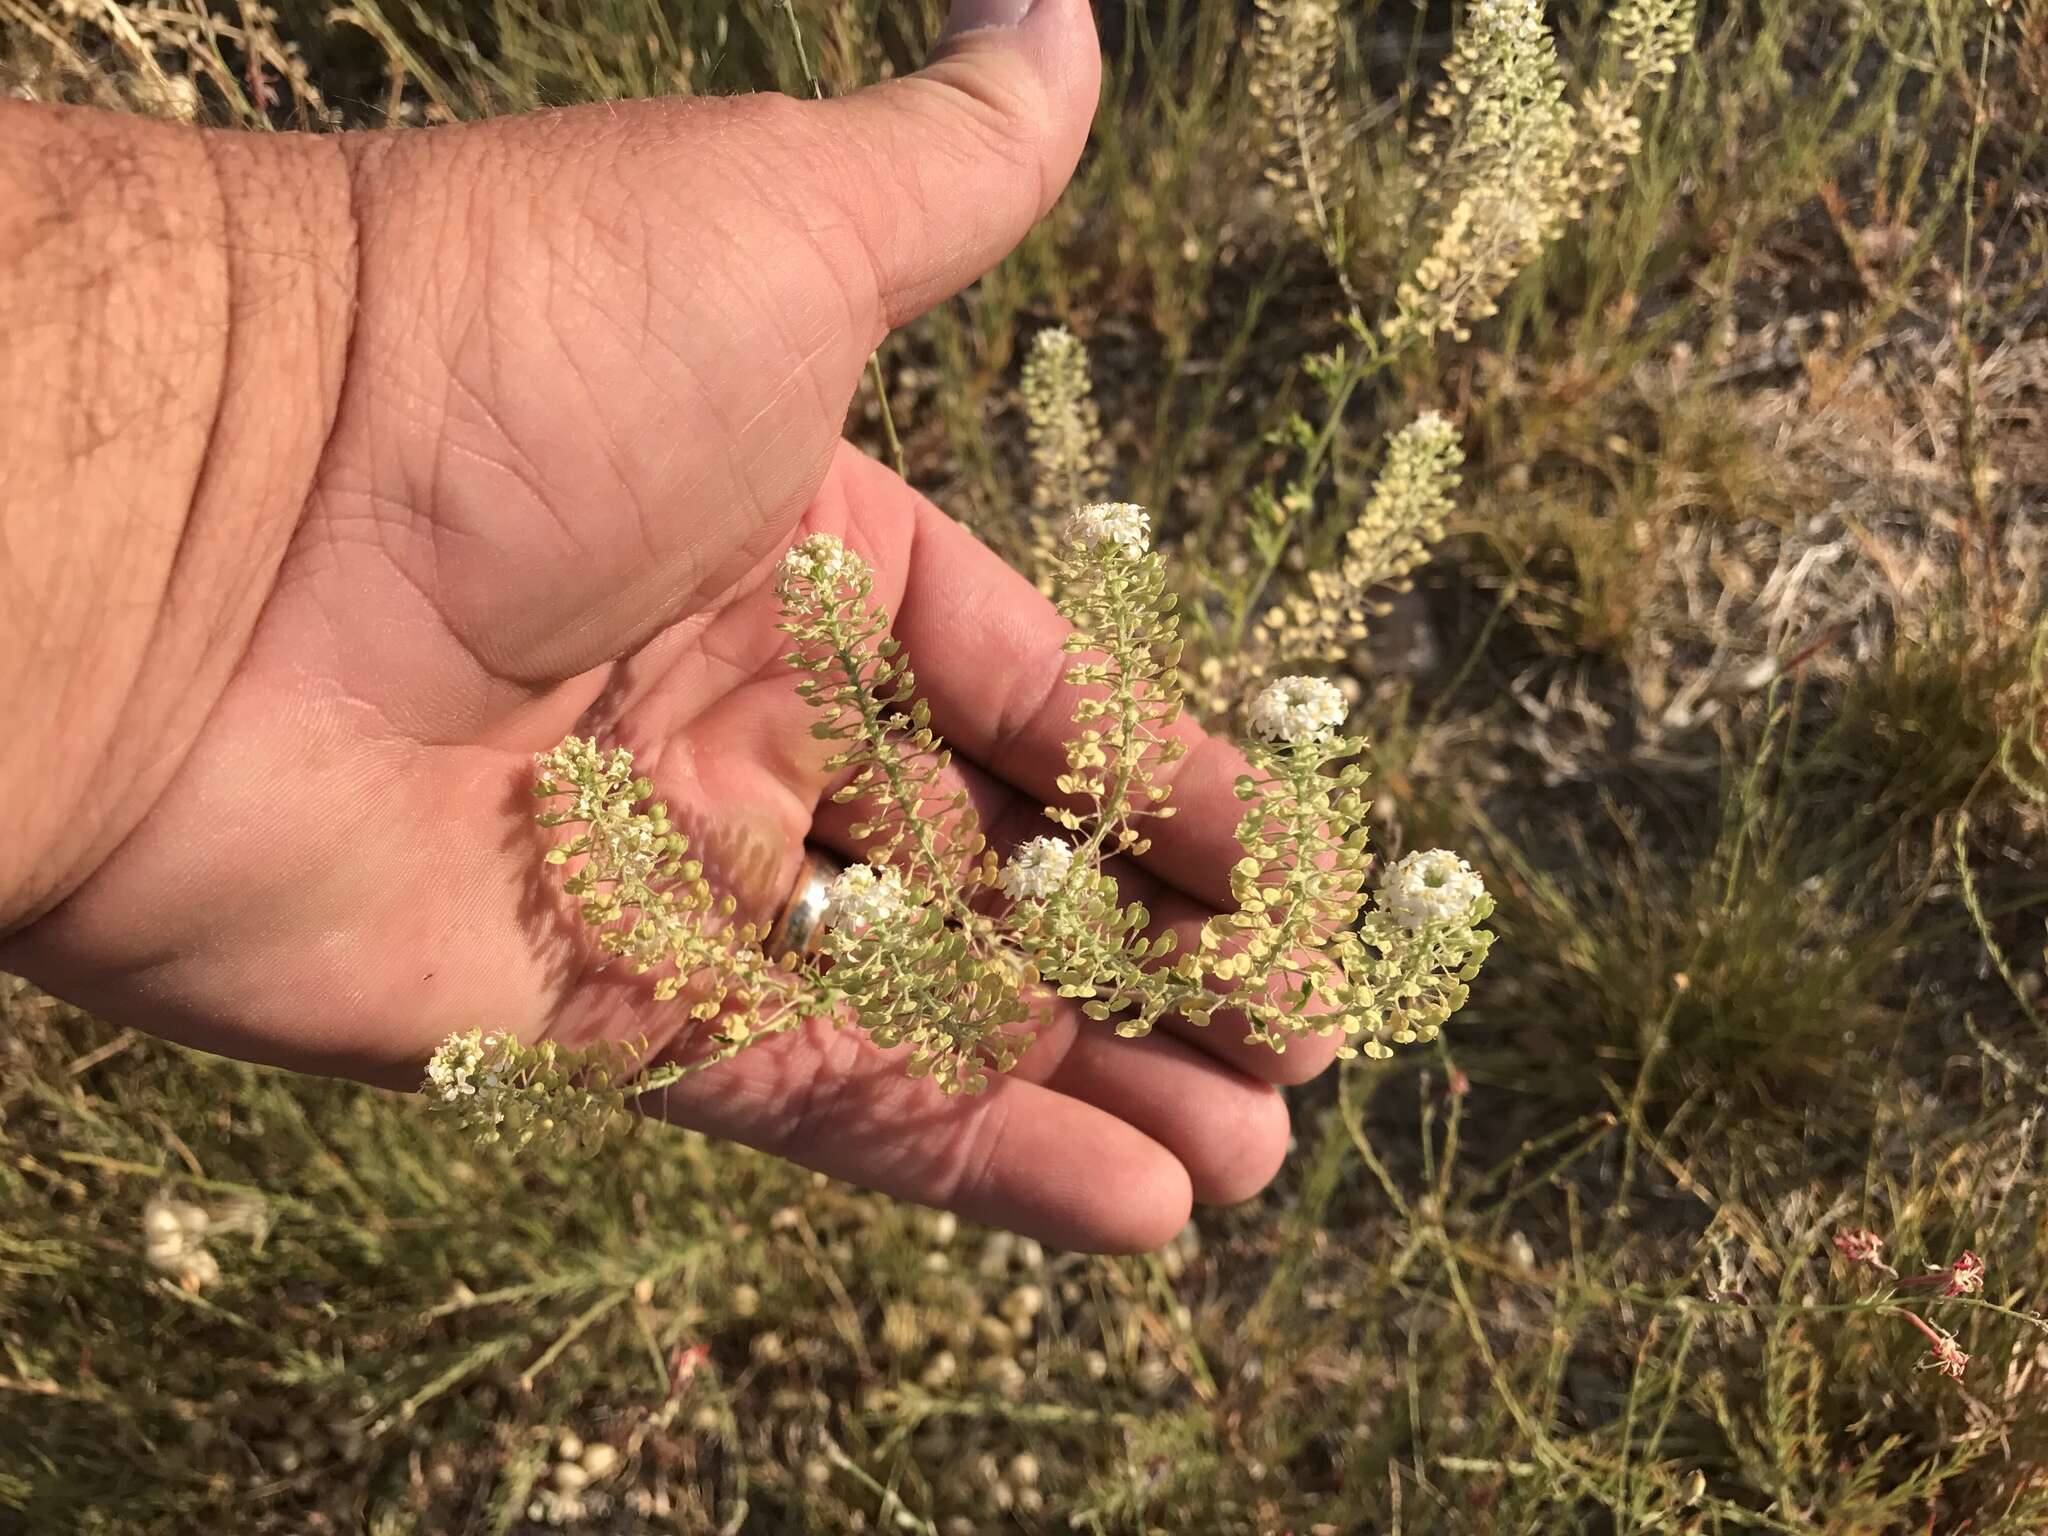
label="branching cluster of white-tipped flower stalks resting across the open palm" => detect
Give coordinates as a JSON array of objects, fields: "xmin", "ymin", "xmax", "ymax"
[{"xmin": 428, "ymin": 504, "xmax": 1491, "ymax": 1139}]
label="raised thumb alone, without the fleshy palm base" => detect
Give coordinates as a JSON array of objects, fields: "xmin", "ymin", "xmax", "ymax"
[{"xmin": 801, "ymin": 0, "xmax": 1102, "ymax": 328}]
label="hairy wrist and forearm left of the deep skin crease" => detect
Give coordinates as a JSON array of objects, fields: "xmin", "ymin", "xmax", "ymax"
[{"xmin": 0, "ymin": 102, "xmax": 354, "ymax": 934}]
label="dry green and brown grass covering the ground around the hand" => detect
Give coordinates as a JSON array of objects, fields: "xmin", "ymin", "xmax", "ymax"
[{"xmin": 0, "ymin": 0, "xmax": 2048, "ymax": 1536}]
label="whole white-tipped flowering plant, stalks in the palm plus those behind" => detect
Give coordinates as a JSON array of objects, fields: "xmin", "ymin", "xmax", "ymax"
[{"xmin": 407, "ymin": 0, "xmax": 1694, "ymax": 1137}]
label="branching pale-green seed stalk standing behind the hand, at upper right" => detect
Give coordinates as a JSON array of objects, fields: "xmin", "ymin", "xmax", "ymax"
[{"xmin": 1192, "ymin": 0, "xmax": 1694, "ymax": 719}]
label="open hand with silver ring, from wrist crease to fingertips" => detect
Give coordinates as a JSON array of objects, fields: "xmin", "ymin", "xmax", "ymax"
[{"xmin": 0, "ymin": 0, "xmax": 1331, "ymax": 1249}]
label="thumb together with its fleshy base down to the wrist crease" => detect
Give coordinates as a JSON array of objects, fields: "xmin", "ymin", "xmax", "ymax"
[{"xmin": 313, "ymin": 0, "xmax": 1100, "ymax": 682}]
